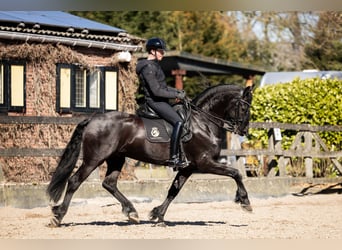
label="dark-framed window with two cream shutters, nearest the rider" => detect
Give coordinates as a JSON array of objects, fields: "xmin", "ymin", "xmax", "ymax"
[{"xmin": 56, "ymin": 64, "xmax": 118, "ymax": 113}]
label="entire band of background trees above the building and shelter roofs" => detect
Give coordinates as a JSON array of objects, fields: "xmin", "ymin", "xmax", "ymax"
[{"xmin": 72, "ymin": 11, "xmax": 342, "ymax": 90}]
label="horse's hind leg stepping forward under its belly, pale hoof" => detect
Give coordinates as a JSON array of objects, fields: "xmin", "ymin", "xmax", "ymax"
[{"xmin": 102, "ymin": 157, "xmax": 140, "ymax": 223}]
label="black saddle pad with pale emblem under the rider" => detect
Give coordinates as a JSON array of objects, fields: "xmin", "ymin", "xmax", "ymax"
[{"xmin": 141, "ymin": 117, "xmax": 170, "ymax": 142}]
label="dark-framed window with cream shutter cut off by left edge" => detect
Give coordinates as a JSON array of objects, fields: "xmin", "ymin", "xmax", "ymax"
[{"xmin": 0, "ymin": 61, "xmax": 26, "ymax": 112}]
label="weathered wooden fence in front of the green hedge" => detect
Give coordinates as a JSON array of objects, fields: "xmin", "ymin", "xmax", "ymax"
[{"xmin": 221, "ymin": 122, "xmax": 342, "ymax": 177}]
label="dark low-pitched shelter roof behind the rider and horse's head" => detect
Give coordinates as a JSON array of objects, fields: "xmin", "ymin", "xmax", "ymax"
[{"xmin": 138, "ymin": 51, "xmax": 265, "ymax": 76}]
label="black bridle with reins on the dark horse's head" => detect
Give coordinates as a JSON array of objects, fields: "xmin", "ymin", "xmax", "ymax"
[{"xmin": 187, "ymin": 98, "xmax": 251, "ymax": 133}]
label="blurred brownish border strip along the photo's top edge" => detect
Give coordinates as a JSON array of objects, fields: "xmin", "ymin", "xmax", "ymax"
[{"xmin": 0, "ymin": 0, "xmax": 342, "ymax": 11}]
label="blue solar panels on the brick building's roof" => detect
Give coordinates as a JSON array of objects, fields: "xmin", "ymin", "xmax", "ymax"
[{"xmin": 0, "ymin": 11, "xmax": 126, "ymax": 33}]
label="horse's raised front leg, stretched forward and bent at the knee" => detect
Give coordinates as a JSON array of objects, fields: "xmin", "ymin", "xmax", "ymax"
[{"xmin": 199, "ymin": 161, "xmax": 253, "ymax": 212}]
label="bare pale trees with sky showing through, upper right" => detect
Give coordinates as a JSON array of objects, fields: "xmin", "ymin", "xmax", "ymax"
[{"xmin": 229, "ymin": 11, "xmax": 318, "ymax": 71}]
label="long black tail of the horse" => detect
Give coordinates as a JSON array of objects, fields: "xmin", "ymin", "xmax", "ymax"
[{"xmin": 46, "ymin": 118, "xmax": 91, "ymax": 203}]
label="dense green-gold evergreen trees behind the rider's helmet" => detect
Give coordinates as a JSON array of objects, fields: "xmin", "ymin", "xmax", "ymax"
[{"xmin": 71, "ymin": 11, "xmax": 245, "ymax": 62}]
